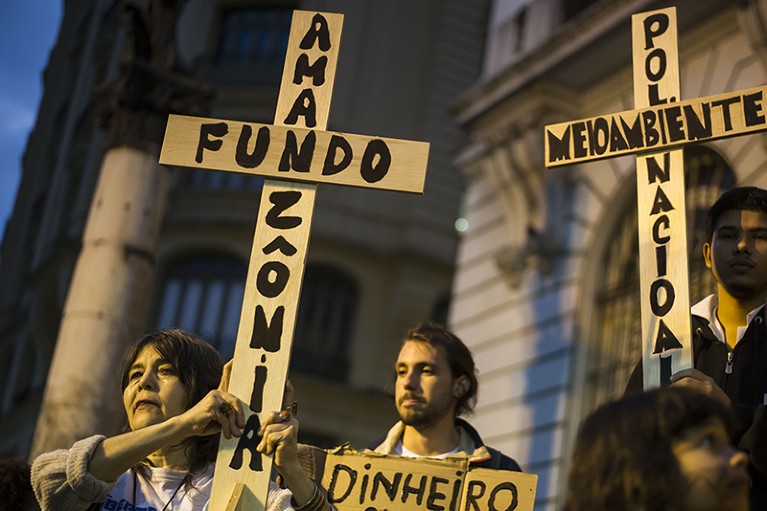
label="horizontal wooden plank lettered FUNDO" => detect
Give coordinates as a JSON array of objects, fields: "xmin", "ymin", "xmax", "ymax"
[{"xmin": 160, "ymin": 115, "xmax": 429, "ymax": 193}]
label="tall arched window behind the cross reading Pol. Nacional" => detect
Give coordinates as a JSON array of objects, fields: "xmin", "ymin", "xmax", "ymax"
[{"xmin": 581, "ymin": 146, "xmax": 735, "ymax": 414}]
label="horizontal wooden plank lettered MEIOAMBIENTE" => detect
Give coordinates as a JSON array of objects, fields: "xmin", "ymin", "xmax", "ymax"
[{"xmin": 545, "ymin": 87, "xmax": 767, "ymax": 167}]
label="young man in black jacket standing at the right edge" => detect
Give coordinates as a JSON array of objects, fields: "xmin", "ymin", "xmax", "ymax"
[{"xmin": 627, "ymin": 187, "xmax": 767, "ymax": 510}]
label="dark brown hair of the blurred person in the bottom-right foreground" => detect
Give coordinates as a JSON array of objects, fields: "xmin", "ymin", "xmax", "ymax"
[{"xmin": 563, "ymin": 387, "xmax": 736, "ymax": 511}]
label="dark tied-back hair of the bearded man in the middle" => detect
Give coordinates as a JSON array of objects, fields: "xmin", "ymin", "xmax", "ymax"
[{"xmin": 402, "ymin": 322, "xmax": 479, "ymax": 416}]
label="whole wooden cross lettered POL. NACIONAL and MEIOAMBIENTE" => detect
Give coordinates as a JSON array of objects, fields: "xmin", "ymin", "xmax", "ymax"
[{"xmin": 544, "ymin": 7, "xmax": 767, "ymax": 388}]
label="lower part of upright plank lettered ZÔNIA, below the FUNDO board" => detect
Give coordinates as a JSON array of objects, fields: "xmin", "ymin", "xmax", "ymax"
[{"xmin": 211, "ymin": 180, "xmax": 316, "ymax": 509}]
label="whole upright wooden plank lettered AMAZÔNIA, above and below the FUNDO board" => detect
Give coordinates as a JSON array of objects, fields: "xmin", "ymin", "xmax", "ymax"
[{"xmin": 209, "ymin": 11, "xmax": 343, "ymax": 511}]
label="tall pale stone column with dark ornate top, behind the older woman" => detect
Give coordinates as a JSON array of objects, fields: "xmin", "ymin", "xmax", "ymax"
[{"xmin": 31, "ymin": 0, "xmax": 211, "ymax": 458}]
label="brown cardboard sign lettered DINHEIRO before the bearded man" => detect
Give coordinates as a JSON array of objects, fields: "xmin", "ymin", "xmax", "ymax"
[{"xmin": 322, "ymin": 450, "xmax": 538, "ymax": 511}]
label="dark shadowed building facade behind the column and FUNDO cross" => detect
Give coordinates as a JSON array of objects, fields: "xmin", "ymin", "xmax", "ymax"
[{"xmin": 0, "ymin": 0, "xmax": 489, "ymax": 457}]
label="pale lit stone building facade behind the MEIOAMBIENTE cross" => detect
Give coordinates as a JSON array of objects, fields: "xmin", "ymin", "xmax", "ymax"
[{"xmin": 450, "ymin": 0, "xmax": 767, "ymax": 510}]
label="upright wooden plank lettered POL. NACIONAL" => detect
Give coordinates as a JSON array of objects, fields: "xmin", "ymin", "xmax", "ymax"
[{"xmin": 631, "ymin": 7, "xmax": 692, "ymax": 389}]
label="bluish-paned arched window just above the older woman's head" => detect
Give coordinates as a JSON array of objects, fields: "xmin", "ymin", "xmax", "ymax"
[{"xmin": 156, "ymin": 254, "xmax": 243, "ymax": 360}]
